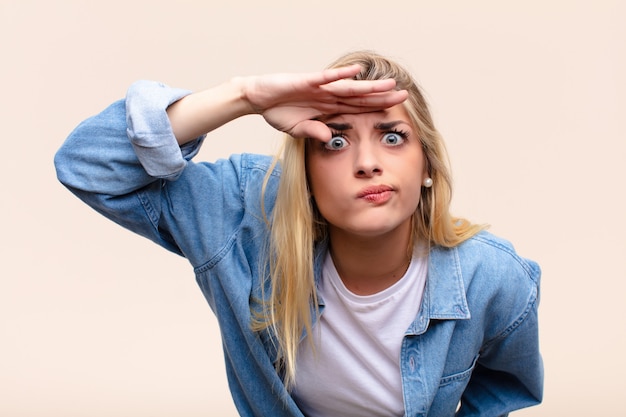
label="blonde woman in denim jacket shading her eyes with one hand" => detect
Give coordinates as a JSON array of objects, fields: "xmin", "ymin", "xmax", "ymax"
[{"xmin": 55, "ymin": 52, "xmax": 543, "ymax": 417}]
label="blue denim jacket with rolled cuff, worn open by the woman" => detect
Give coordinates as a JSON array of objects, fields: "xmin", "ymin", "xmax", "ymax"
[{"xmin": 55, "ymin": 81, "xmax": 543, "ymax": 417}]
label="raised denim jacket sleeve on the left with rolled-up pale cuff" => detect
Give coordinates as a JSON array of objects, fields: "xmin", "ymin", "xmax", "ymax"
[{"xmin": 54, "ymin": 81, "xmax": 204, "ymax": 253}]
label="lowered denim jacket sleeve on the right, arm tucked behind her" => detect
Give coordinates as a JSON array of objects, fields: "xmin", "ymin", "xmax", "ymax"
[{"xmin": 457, "ymin": 262, "xmax": 543, "ymax": 417}]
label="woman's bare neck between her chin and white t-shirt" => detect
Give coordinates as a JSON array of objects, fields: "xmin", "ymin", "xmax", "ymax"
[{"xmin": 329, "ymin": 225, "xmax": 412, "ymax": 295}]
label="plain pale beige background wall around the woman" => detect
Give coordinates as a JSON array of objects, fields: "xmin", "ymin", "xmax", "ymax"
[{"xmin": 0, "ymin": 0, "xmax": 626, "ymax": 417}]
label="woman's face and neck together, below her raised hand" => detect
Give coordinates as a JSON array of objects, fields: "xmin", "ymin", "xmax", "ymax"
[{"xmin": 307, "ymin": 104, "xmax": 427, "ymax": 295}]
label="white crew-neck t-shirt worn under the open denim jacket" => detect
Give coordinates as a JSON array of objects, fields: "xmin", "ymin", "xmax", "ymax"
[{"xmin": 293, "ymin": 249, "xmax": 428, "ymax": 417}]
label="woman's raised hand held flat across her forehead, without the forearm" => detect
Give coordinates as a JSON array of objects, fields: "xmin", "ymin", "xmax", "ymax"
[{"xmin": 239, "ymin": 65, "xmax": 408, "ymax": 141}]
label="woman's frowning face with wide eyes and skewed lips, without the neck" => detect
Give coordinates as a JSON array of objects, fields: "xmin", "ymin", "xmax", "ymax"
[{"xmin": 306, "ymin": 104, "xmax": 426, "ymax": 237}]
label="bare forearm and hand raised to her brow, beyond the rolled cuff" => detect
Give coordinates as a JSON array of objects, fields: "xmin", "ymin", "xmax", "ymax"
[{"xmin": 167, "ymin": 65, "xmax": 407, "ymax": 144}]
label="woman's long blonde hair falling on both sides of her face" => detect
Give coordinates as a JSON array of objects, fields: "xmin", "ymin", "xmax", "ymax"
[{"xmin": 253, "ymin": 51, "xmax": 483, "ymax": 388}]
